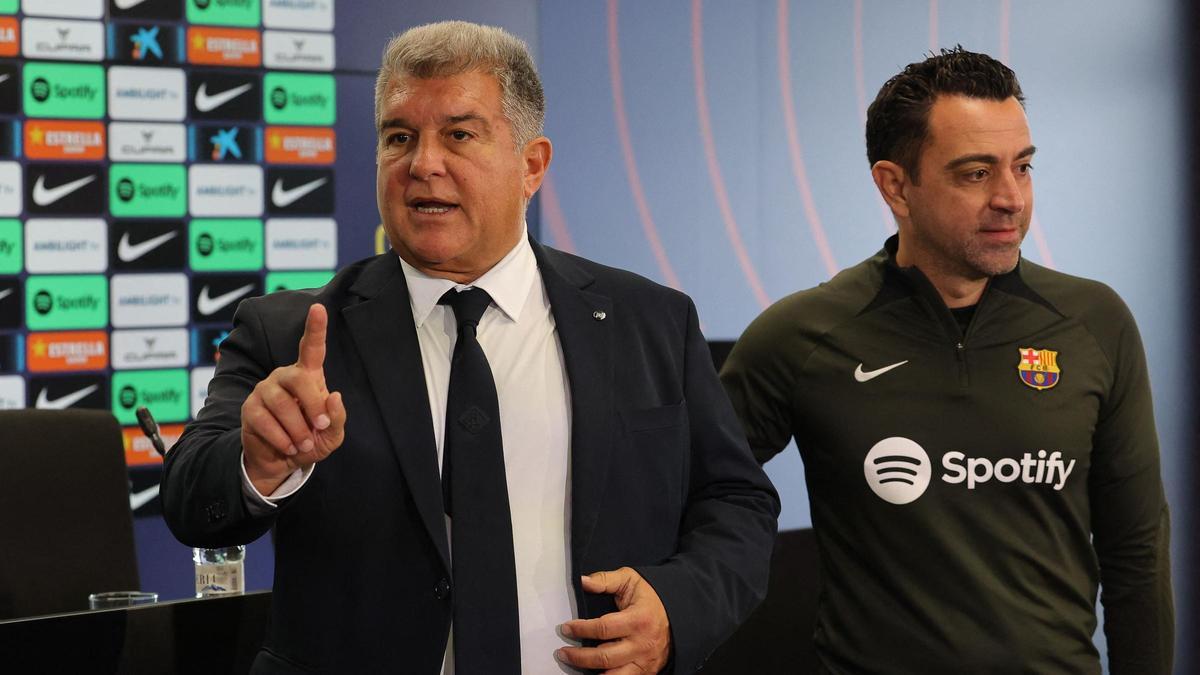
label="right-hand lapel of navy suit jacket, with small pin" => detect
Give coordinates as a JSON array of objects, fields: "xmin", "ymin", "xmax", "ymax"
[{"xmin": 530, "ymin": 239, "xmax": 614, "ymax": 563}]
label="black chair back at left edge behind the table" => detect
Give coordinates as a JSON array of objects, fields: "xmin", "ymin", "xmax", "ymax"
[{"xmin": 0, "ymin": 410, "xmax": 138, "ymax": 620}]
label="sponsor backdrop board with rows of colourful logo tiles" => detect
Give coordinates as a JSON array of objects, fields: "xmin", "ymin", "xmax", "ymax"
[{"xmin": 0, "ymin": 0, "xmax": 360, "ymax": 598}]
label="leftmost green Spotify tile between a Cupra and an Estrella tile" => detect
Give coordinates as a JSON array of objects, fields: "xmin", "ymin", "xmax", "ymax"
[{"xmin": 23, "ymin": 61, "xmax": 106, "ymax": 119}]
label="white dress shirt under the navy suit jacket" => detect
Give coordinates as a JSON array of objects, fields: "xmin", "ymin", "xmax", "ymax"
[{"xmin": 242, "ymin": 233, "xmax": 577, "ymax": 674}]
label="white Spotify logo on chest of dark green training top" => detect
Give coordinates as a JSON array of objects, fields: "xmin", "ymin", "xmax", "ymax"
[{"xmin": 863, "ymin": 436, "xmax": 1075, "ymax": 504}]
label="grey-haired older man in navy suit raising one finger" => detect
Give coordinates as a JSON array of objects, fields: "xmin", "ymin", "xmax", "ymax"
[{"xmin": 162, "ymin": 22, "xmax": 779, "ymax": 673}]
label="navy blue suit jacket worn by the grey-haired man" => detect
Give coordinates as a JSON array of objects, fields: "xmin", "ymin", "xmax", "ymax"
[{"xmin": 162, "ymin": 236, "xmax": 779, "ymax": 673}]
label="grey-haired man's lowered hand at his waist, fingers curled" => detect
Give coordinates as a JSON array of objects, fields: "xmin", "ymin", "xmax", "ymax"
[{"xmin": 556, "ymin": 567, "xmax": 671, "ymax": 674}]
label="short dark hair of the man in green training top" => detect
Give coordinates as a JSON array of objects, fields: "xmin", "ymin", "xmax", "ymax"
[{"xmin": 866, "ymin": 44, "xmax": 1025, "ymax": 183}]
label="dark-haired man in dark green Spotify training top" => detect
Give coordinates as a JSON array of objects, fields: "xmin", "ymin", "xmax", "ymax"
[{"xmin": 721, "ymin": 48, "xmax": 1174, "ymax": 674}]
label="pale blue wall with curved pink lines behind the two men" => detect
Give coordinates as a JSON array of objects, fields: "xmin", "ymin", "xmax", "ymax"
[{"xmin": 539, "ymin": 0, "xmax": 1196, "ymax": 668}]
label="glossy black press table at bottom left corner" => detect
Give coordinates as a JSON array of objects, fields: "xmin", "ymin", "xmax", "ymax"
[{"xmin": 0, "ymin": 591, "xmax": 271, "ymax": 675}]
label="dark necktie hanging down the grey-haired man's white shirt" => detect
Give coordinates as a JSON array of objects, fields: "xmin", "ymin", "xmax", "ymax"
[{"xmin": 439, "ymin": 288, "xmax": 521, "ymax": 675}]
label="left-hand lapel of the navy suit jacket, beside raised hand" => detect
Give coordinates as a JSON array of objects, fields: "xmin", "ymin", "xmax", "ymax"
[{"xmin": 342, "ymin": 253, "xmax": 450, "ymax": 571}]
